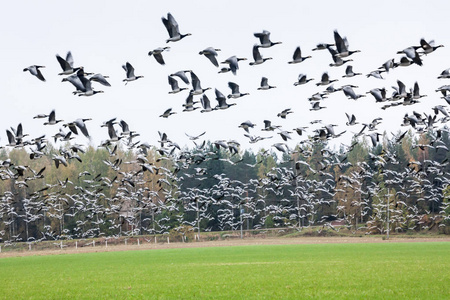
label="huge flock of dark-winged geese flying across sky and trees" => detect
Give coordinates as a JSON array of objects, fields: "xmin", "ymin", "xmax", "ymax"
[{"xmin": 0, "ymin": 13, "xmax": 450, "ymax": 245}]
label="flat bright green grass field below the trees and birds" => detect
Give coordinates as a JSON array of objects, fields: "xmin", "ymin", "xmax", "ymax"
[{"xmin": 0, "ymin": 242, "xmax": 450, "ymax": 299}]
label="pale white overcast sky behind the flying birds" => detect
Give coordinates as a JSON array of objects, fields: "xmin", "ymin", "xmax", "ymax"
[{"xmin": 0, "ymin": 0, "xmax": 450, "ymax": 150}]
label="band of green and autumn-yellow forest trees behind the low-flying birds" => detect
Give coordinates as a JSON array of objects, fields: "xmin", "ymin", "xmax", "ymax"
[{"xmin": 0, "ymin": 129, "xmax": 450, "ymax": 245}]
